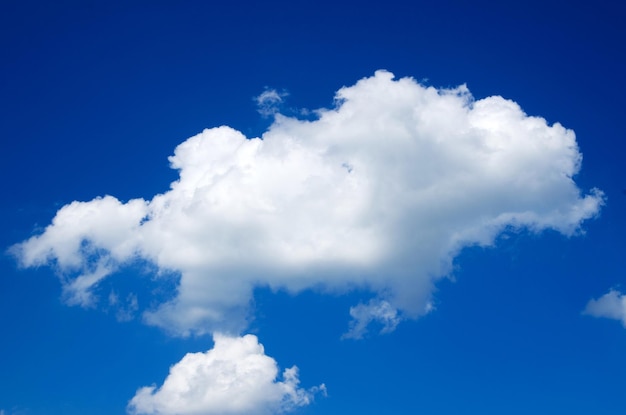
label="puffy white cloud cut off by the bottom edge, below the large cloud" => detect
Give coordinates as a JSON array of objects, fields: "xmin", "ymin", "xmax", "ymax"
[{"xmin": 128, "ymin": 334, "xmax": 326, "ymax": 415}]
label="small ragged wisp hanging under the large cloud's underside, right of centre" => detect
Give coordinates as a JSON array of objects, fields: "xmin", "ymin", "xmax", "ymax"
[{"xmin": 342, "ymin": 299, "xmax": 400, "ymax": 339}]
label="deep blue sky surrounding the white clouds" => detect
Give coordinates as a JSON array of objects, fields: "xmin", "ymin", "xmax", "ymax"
[{"xmin": 0, "ymin": 1, "xmax": 626, "ymax": 415}]
